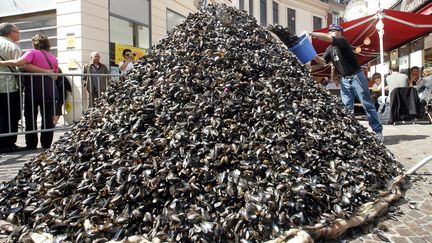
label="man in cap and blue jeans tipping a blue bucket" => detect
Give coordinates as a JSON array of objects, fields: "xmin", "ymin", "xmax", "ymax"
[{"xmin": 310, "ymin": 24, "xmax": 384, "ymax": 142}]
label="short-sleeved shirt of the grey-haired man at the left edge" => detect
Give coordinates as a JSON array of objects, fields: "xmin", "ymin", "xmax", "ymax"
[{"xmin": 0, "ymin": 36, "xmax": 21, "ymax": 93}]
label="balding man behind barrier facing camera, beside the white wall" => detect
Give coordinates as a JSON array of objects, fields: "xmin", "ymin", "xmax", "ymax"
[{"xmin": 83, "ymin": 52, "xmax": 109, "ymax": 107}]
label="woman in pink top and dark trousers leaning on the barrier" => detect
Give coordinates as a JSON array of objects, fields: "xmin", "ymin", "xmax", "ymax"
[{"xmin": 0, "ymin": 34, "xmax": 59, "ymax": 149}]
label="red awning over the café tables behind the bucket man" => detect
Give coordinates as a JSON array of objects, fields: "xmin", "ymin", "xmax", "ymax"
[{"xmin": 312, "ymin": 9, "xmax": 432, "ymax": 75}]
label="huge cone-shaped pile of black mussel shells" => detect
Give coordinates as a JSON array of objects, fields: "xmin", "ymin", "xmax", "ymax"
[{"xmin": 0, "ymin": 5, "xmax": 402, "ymax": 242}]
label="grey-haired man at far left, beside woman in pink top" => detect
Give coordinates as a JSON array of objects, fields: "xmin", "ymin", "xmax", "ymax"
[{"xmin": 0, "ymin": 23, "xmax": 21, "ymax": 151}]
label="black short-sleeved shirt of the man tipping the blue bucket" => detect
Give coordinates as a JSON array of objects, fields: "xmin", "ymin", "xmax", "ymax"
[{"xmin": 323, "ymin": 36, "xmax": 361, "ymax": 76}]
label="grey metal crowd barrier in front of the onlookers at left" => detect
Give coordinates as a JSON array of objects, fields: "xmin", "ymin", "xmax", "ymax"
[{"xmin": 0, "ymin": 72, "xmax": 121, "ymax": 137}]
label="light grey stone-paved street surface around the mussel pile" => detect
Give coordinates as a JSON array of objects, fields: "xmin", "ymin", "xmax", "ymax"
[{"xmin": 0, "ymin": 121, "xmax": 432, "ymax": 243}]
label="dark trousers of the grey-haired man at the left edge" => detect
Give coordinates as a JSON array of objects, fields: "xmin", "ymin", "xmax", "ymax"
[{"xmin": 0, "ymin": 91, "xmax": 21, "ymax": 148}]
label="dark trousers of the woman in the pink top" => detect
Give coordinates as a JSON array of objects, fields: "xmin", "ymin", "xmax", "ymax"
[{"xmin": 24, "ymin": 99, "xmax": 55, "ymax": 148}]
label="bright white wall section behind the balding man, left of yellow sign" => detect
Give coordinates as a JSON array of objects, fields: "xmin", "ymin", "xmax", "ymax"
[{"xmin": 56, "ymin": 0, "xmax": 109, "ymax": 73}]
